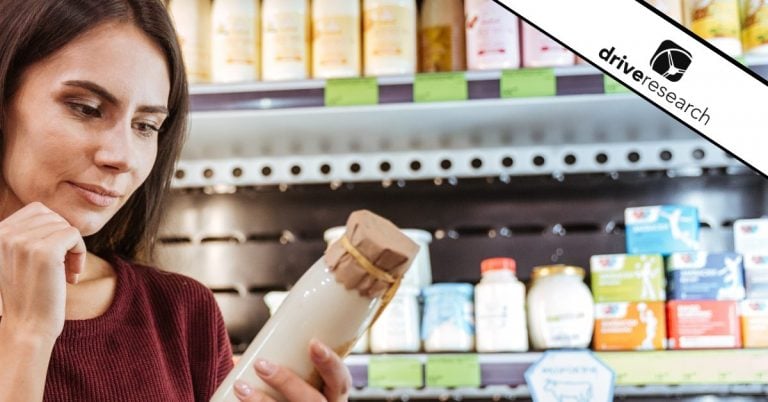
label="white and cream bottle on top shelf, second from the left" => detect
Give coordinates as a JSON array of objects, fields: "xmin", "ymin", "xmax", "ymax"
[{"xmin": 211, "ymin": 0, "xmax": 260, "ymax": 82}]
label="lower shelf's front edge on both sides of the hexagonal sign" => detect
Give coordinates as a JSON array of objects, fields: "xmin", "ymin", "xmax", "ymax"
[{"xmin": 345, "ymin": 350, "xmax": 768, "ymax": 400}]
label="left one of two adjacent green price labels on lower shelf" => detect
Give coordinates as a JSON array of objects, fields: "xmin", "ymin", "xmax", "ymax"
[{"xmin": 368, "ymin": 356, "xmax": 424, "ymax": 388}]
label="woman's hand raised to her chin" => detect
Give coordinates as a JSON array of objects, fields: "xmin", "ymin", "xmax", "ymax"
[{"xmin": 0, "ymin": 202, "xmax": 86, "ymax": 342}]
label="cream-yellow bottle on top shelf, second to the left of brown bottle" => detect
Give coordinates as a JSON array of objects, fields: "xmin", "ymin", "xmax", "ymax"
[{"xmin": 312, "ymin": 0, "xmax": 362, "ymax": 78}]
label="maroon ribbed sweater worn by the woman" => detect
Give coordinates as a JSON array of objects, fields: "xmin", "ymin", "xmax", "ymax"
[{"xmin": 26, "ymin": 258, "xmax": 233, "ymax": 402}]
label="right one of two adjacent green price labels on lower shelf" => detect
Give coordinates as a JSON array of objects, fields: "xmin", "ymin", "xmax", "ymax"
[{"xmin": 427, "ymin": 354, "xmax": 481, "ymax": 388}]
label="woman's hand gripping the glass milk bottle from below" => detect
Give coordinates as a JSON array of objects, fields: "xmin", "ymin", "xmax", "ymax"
[{"xmin": 235, "ymin": 340, "xmax": 352, "ymax": 402}]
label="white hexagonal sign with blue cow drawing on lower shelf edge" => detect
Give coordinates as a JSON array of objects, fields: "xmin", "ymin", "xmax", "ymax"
[{"xmin": 525, "ymin": 351, "xmax": 615, "ymax": 402}]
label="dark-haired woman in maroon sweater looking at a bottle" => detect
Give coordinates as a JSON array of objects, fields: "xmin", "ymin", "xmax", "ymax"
[{"xmin": 0, "ymin": 0, "xmax": 350, "ymax": 402}]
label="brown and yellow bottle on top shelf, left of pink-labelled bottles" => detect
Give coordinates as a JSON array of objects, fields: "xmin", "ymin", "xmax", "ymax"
[{"xmin": 419, "ymin": 0, "xmax": 467, "ymax": 72}]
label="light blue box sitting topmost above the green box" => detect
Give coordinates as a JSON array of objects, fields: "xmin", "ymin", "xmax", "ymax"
[{"xmin": 624, "ymin": 205, "xmax": 699, "ymax": 255}]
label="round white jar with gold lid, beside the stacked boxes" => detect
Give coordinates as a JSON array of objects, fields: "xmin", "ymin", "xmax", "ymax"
[{"xmin": 528, "ymin": 265, "xmax": 595, "ymax": 350}]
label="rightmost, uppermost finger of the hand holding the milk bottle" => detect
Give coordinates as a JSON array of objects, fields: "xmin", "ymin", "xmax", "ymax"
[{"xmin": 309, "ymin": 339, "xmax": 352, "ymax": 402}]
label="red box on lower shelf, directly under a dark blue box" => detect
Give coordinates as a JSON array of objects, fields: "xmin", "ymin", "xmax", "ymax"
[{"xmin": 667, "ymin": 300, "xmax": 741, "ymax": 349}]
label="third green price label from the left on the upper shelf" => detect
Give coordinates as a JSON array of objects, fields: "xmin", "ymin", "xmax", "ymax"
[{"xmin": 501, "ymin": 68, "xmax": 557, "ymax": 98}]
